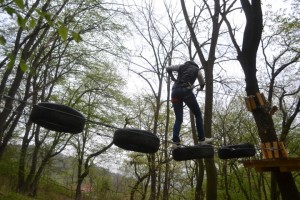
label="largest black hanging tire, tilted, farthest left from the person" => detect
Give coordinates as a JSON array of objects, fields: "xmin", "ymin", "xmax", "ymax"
[{"xmin": 30, "ymin": 102, "xmax": 85, "ymax": 134}]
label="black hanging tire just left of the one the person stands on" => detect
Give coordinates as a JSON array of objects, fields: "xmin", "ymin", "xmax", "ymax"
[{"xmin": 113, "ymin": 128, "xmax": 160, "ymax": 153}]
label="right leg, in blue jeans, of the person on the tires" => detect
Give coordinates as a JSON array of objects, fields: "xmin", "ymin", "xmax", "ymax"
[{"xmin": 184, "ymin": 91, "xmax": 205, "ymax": 141}]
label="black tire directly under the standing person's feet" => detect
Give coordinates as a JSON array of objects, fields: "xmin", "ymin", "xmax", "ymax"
[{"xmin": 172, "ymin": 145, "xmax": 214, "ymax": 161}]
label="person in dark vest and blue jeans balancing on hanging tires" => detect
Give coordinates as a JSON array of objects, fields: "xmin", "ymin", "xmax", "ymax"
[{"xmin": 166, "ymin": 61, "xmax": 213, "ymax": 149}]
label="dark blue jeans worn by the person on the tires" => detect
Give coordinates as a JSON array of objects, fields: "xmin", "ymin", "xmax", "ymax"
[{"xmin": 171, "ymin": 87, "xmax": 204, "ymax": 142}]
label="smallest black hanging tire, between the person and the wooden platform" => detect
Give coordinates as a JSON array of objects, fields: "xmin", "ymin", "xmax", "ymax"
[{"xmin": 218, "ymin": 143, "xmax": 255, "ymax": 159}]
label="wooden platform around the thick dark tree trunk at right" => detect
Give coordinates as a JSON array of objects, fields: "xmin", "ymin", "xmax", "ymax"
[{"xmin": 242, "ymin": 158, "xmax": 300, "ymax": 172}]
